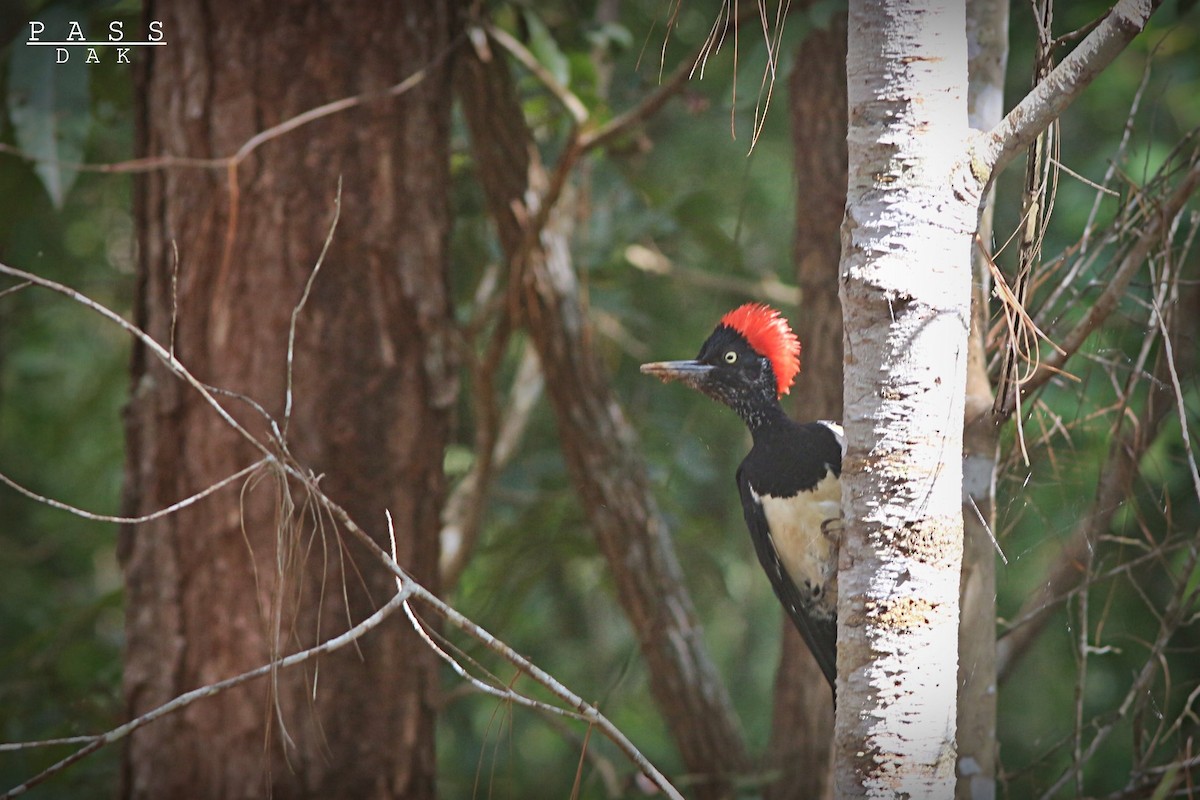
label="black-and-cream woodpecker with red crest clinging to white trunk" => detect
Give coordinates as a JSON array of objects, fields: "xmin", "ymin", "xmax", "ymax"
[{"xmin": 642, "ymin": 303, "xmax": 845, "ymax": 691}]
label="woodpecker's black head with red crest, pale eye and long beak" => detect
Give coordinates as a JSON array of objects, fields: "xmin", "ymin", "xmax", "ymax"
[{"xmin": 642, "ymin": 303, "xmax": 800, "ymax": 416}]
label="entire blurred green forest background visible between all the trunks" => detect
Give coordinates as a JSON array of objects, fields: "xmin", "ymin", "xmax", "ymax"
[{"xmin": 0, "ymin": 0, "xmax": 1200, "ymax": 798}]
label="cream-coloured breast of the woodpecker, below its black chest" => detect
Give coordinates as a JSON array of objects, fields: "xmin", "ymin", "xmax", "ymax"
[{"xmin": 750, "ymin": 470, "xmax": 841, "ymax": 614}]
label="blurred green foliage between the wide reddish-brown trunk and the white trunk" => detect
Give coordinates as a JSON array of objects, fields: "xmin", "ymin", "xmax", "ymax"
[{"xmin": 439, "ymin": 2, "xmax": 811, "ymax": 796}]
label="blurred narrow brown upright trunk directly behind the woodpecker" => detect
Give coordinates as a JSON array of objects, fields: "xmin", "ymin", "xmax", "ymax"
[{"xmin": 767, "ymin": 2, "xmax": 846, "ymax": 800}]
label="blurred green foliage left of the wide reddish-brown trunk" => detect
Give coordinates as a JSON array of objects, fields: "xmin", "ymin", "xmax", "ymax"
[{"xmin": 0, "ymin": 6, "xmax": 136, "ymax": 798}]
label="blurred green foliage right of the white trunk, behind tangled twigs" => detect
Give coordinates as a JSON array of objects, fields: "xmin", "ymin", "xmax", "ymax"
[{"xmin": 996, "ymin": 4, "xmax": 1200, "ymax": 798}]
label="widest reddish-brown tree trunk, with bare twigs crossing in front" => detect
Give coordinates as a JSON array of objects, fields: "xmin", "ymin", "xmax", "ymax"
[{"xmin": 121, "ymin": 0, "xmax": 457, "ymax": 799}]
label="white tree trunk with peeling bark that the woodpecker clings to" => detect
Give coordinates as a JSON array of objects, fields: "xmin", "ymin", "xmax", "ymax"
[{"xmin": 834, "ymin": 0, "xmax": 980, "ymax": 798}]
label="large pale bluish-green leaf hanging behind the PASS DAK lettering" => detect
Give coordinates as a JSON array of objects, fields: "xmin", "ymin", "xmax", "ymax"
[{"xmin": 7, "ymin": 6, "xmax": 91, "ymax": 209}]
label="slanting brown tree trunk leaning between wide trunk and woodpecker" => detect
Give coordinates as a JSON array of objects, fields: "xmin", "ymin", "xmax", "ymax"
[{"xmin": 458, "ymin": 34, "xmax": 749, "ymax": 798}]
